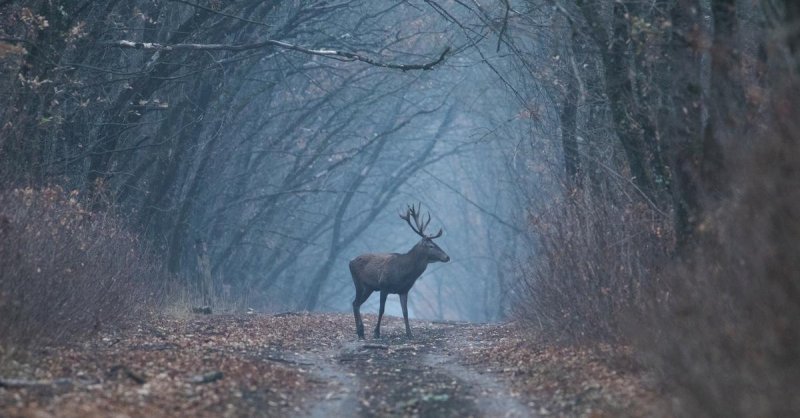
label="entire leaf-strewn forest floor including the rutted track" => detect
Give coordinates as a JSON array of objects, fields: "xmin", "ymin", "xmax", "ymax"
[{"xmin": 0, "ymin": 313, "xmax": 663, "ymax": 417}]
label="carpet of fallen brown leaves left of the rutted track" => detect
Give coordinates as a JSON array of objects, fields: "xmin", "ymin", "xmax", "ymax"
[{"xmin": 0, "ymin": 315, "xmax": 351, "ymax": 417}]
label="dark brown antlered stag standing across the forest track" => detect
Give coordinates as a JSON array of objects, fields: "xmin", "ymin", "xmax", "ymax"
[{"xmin": 350, "ymin": 203, "xmax": 450, "ymax": 340}]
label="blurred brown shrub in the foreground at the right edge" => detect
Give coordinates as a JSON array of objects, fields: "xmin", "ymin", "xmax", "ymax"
[{"xmin": 633, "ymin": 125, "xmax": 800, "ymax": 416}]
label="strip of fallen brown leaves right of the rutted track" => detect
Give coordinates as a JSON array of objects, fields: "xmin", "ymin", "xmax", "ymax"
[{"xmin": 450, "ymin": 324, "xmax": 667, "ymax": 417}]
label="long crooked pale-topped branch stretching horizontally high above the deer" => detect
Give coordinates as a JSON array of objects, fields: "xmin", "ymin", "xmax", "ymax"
[{"xmin": 105, "ymin": 39, "xmax": 450, "ymax": 71}]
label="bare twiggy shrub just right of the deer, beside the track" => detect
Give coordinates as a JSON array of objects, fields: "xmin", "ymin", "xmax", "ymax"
[{"xmin": 514, "ymin": 185, "xmax": 672, "ymax": 343}]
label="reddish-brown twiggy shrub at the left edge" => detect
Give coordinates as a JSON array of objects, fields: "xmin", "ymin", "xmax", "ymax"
[{"xmin": 0, "ymin": 187, "xmax": 158, "ymax": 346}]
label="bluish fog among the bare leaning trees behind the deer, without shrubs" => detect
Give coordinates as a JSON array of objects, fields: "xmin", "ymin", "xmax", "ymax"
[{"xmin": 2, "ymin": 1, "xmax": 561, "ymax": 321}]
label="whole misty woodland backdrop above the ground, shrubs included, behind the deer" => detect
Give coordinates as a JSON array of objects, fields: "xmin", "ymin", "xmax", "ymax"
[{"xmin": 0, "ymin": 0, "xmax": 800, "ymax": 415}]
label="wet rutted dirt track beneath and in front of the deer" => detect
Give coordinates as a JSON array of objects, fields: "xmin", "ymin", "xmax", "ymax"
[{"xmin": 300, "ymin": 317, "xmax": 533, "ymax": 418}]
